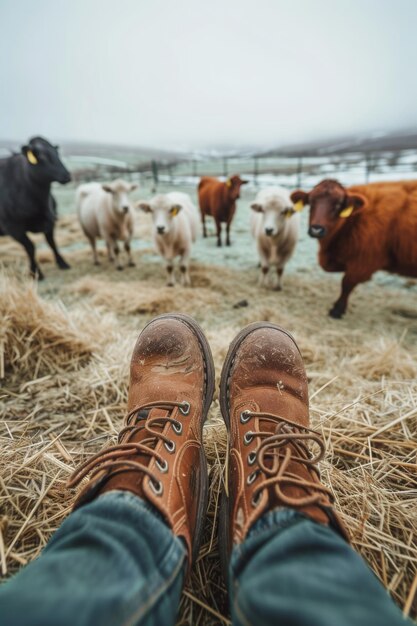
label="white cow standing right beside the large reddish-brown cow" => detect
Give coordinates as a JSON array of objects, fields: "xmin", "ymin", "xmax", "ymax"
[{"xmin": 251, "ymin": 187, "xmax": 300, "ymax": 290}]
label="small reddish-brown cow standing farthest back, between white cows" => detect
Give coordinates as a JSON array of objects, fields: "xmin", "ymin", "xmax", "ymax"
[{"xmin": 198, "ymin": 176, "xmax": 249, "ymax": 246}]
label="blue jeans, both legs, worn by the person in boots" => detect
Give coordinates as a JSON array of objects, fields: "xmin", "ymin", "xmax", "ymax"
[{"xmin": 0, "ymin": 491, "xmax": 405, "ymax": 626}]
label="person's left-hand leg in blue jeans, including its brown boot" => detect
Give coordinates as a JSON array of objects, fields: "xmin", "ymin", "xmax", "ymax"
[{"xmin": 0, "ymin": 314, "xmax": 214, "ymax": 626}]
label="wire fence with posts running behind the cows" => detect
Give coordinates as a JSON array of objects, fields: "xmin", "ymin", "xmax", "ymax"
[{"xmin": 68, "ymin": 150, "xmax": 417, "ymax": 189}]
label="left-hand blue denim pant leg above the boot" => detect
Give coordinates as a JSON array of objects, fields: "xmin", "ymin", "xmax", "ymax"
[{"xmin": 0, "ymin": 491, "xmax": 186, "ymax": 626}]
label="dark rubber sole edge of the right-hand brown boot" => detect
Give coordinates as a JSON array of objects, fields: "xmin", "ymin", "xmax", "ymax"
[{"xmin": 218, "ymin": 322, "xmax": 301, "ymax": 584}]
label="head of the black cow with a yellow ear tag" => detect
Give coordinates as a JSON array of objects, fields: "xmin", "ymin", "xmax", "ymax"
[{"xmin": 22, "ymin": 137, "xmax": 71, "ymax": 185}]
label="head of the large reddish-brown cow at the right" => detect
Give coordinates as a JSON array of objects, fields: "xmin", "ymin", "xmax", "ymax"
[{"xmin": 291, "ymin": 179, "xmax": 366, "ymax": 239}]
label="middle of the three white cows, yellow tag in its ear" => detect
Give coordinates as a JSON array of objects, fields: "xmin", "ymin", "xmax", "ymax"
[{"xmin": 136, "ymin": 191, "xmax": 199, "ymax": 287}]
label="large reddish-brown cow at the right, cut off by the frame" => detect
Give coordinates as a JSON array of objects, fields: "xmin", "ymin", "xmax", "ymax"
[{"xmin": 291, "ymin": 180, "xmax": 417, "ymax": 318}]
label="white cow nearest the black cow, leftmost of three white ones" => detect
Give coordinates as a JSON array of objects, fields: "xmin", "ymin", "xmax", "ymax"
[{"xmin": 76, "ymin": 179, "xmax": 137, "ymax": 270}]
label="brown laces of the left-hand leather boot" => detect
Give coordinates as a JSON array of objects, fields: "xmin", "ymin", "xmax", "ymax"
[{"xmin": 68, "ymin": 400, "xmax": 190, "ymax": 495}]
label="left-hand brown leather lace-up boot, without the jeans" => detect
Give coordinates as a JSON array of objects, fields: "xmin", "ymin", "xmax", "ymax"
[{"xmin": 69, "ymin": 314, "xmax": 214, "ymax": 564}]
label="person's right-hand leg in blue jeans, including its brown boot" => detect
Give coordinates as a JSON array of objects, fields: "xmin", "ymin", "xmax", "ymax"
[{"xmin": 219, "ymin": 322, "xmax": 410, "ymax": 626}]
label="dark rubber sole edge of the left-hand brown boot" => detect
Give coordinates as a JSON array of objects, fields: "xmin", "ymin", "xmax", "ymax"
[{"xmin": 145, "ymin": 313, "xmax": 215, "ymax": 566}]
